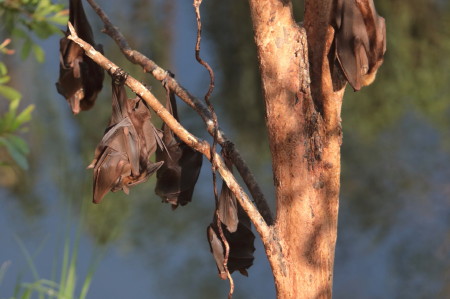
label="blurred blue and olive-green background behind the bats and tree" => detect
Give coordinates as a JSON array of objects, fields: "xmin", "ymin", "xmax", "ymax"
[{"xmin": 0, "ymin": 0, "xmax": 450, "ymax": 298}]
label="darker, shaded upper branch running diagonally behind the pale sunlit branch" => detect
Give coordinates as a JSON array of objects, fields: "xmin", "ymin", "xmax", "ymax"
[{"xmin": 87, "ymin": 0, "xmax": 274, "ymax": 225}]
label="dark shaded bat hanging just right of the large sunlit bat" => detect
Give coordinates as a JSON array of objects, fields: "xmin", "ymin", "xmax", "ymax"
[{"xmin": 155, "ymin": 75, "xmax": 203, "ymax": 209}]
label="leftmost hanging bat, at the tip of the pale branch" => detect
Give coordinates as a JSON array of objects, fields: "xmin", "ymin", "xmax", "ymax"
[{"xmin": 56, "ymin": 0, "xmax": 105, "ymax": 114}]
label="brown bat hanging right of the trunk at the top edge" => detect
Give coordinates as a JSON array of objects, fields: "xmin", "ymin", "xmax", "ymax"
[{"xmin": 331, "ymin": 0, "xmax": 386, "ymax": 91}]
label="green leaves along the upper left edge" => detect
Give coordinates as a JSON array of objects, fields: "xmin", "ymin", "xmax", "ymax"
[{"xmin": 0, "ymin": 0, "xmax": 67, "ymax": 169}]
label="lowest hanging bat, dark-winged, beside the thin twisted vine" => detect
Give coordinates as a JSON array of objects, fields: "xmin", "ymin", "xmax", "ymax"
[{"xmin": 207, "ymin": 155, "xmax": 255, "ymax": 279}]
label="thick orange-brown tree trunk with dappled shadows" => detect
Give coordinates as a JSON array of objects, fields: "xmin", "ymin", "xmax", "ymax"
[{"xmin": 249, "ymin": 0, "xmax": 343, "ymax": 298}]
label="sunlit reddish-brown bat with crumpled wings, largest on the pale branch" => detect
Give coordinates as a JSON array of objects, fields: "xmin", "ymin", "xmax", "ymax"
[{"xmin": 88, "ymin": 72, "xmax": 164, "ymax": 203}]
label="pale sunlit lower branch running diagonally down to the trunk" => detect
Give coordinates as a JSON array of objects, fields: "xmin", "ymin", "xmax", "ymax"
[{"xmin": 67, "ymin": 23, "xmax": 273, "ymax": 253}]
